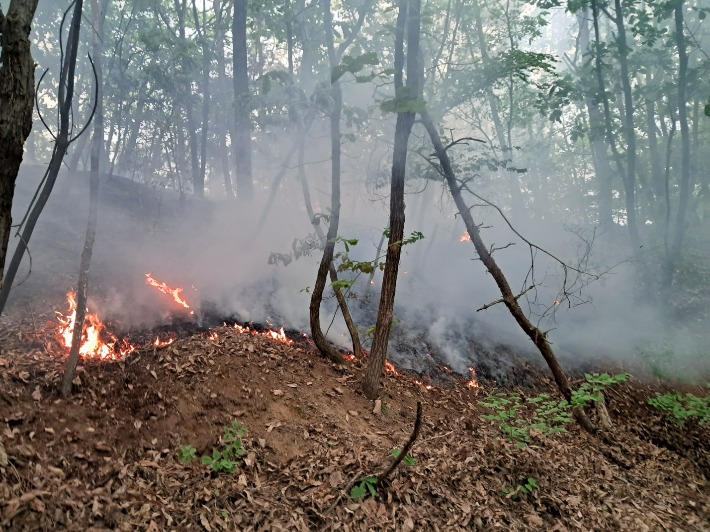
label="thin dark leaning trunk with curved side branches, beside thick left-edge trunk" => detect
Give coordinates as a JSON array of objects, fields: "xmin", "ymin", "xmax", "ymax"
[{"xmin": 0, "ymin": 0, "xmax": 84, "ymax": 314}]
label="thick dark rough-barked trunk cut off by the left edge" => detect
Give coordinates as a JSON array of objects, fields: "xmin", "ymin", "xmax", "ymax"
[{"xmin": 0, "ymin": 0, "xmax": 39, "ymax": 289}]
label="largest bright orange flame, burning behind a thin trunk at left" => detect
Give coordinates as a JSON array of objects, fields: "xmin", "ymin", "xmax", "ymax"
[{"xmin": 57, "ymin": 292, "xmax": 136, "ymax": 360}]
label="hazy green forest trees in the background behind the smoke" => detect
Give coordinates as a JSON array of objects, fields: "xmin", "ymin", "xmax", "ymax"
[{"xmin": 8, "ymin": 0, "xmax": 710, "ymax": 378}]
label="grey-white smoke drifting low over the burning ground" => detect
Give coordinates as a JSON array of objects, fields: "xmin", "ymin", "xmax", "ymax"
[{"xmin": 11, "ymin": 141, "xmax": 708, "ymax": 382}]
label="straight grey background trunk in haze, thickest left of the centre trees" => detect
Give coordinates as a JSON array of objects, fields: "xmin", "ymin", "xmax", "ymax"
[{"xmin": 232, "ymin": 0, "xmax": 254, "ymax": 202}]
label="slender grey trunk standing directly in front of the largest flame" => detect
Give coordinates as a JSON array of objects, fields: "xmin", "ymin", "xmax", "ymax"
[{"xmin": 61, "ymin": 0, "xmax": 108, "ymax": 397}]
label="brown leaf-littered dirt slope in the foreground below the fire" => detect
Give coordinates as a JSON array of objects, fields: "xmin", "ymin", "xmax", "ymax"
[{"xmin": 0, "ymin": 302, "xmax": 710, "ymax": 531}]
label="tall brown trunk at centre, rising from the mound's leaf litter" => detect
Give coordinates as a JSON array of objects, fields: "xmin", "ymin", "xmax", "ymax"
[{"xmin": 362, "ymin": 0, "xmax": 421, "ymax": 399}]
